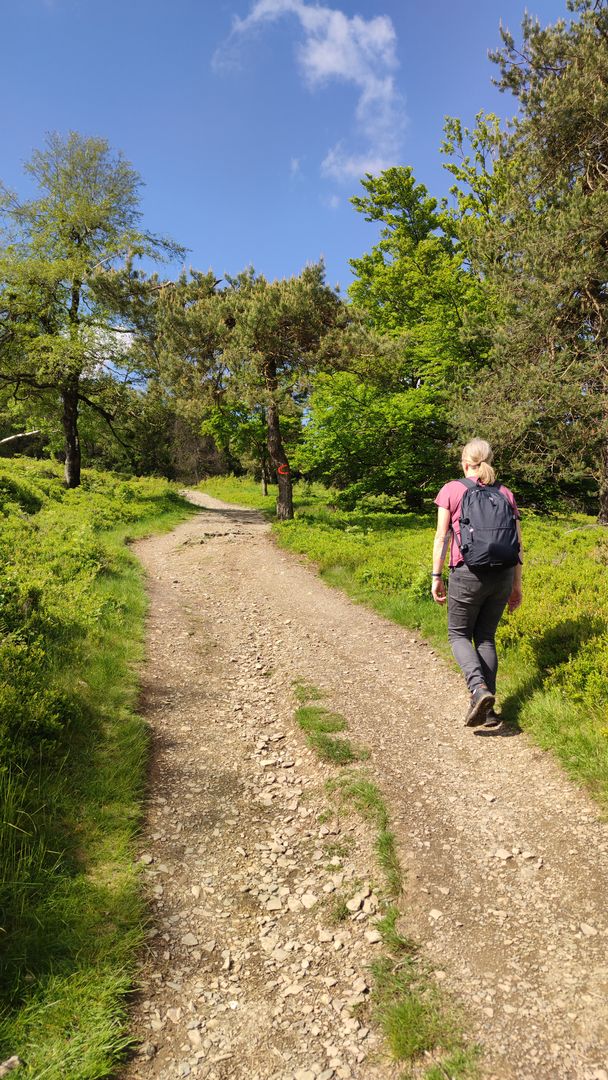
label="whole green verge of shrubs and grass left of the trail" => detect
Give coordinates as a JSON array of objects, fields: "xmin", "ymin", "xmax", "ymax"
[{"xmin": 0, "ymin": 462, "xmax": 193, "ymax": 1080}]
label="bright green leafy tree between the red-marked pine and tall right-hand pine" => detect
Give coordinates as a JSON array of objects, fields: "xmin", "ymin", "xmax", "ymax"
[{"xmin": 297, "ymin": 167, "xmax": 487, "ymax": 507}]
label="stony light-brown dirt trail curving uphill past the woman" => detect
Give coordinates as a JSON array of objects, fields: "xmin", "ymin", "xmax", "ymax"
[{"xmin": 124, "ymin": 494, "xmax": 608, "ymax": 1080}]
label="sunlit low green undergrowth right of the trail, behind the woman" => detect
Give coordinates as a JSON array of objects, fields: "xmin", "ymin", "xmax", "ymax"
[{"xmin": 201, "ymin": 477, "xmax": 608, "ymax": 807}]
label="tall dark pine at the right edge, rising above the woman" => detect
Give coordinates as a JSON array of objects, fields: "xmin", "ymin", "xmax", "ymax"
[{"xmin": 444, "ymin": 0, "xmax": 608, "ymax": 514}]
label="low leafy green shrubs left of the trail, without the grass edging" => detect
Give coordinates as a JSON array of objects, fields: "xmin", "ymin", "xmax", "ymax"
[{"xmin": 0, "ymin": 462, "xmax": 185, "ymax": 762}]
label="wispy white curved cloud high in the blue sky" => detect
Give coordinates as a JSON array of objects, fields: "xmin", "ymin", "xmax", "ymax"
[{"xmin": 214, "ymin": 0, "xmax": 406, "ymax": 180}]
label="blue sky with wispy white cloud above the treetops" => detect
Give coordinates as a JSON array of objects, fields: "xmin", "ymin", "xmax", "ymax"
[{"xmin": 0, "ymin": 0, "xmax": 566, "ymax": 288}]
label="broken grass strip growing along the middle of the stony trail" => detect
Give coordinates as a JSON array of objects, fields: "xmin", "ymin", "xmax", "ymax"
[{"xmin": 294, "ymin": 681, "xmax": 478, "ymax": 1080}]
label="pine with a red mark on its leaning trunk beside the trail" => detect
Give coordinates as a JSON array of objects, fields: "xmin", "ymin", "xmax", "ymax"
[{"xmin": 158, "ymin": 265, "xmax": 344, "ymax": 518}]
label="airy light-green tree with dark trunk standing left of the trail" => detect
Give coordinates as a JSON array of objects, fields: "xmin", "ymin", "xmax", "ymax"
[{"xmin": 0, "ymin": 133, "xmax": 181, "ymax": 487}]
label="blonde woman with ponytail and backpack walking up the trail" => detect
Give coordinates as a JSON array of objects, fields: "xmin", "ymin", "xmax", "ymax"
[{"xmin": 432, "ymin": 438, "xmax": 522, "ymax": 727}]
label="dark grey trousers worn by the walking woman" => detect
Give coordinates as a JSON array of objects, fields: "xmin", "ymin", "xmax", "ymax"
[{"xmin": 447, "ymin": 564, "xmax": 515, "ymax": 693}]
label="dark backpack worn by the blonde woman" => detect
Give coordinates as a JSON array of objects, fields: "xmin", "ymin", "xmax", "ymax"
[{"xmin": 459, "ymin": 478, "xmax": 519, "ymax": 570}]
